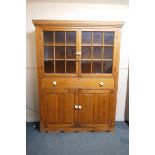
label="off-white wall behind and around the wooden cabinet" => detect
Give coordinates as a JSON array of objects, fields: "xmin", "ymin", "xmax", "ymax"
[{"xmin": 26, "ymin": 0, "xmax": 129, "ymax": 122}]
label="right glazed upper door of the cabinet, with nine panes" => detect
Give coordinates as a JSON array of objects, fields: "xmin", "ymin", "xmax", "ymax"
[{"xmin": 79, "ymin": 29, "xmax": 116, "ymax": 77}]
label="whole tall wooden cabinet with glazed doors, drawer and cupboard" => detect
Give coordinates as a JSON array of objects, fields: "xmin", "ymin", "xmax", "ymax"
[{"xmin": 33, "ymin": 20, "xmax": 123, "ymax": 131}]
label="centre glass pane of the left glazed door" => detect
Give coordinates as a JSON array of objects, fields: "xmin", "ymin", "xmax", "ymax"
[{"xmin": 55, "ymin": 46, "xmax": 65, "ymax": 59}]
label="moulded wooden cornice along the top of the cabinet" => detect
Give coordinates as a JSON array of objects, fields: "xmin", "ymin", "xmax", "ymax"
[{"xmin": 32, "ymin": 20, "xmax": 124, "ymax": 28}]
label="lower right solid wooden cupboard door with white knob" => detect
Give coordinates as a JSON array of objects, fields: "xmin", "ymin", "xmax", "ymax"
[{"xmin": 78, "ymin": 90, "xmax": 110, "ymax": 127}]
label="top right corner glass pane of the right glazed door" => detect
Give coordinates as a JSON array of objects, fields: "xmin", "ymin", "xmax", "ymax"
[{"xmin": 104, "ymin": 32, "xmax": 114, "ymax": 45}]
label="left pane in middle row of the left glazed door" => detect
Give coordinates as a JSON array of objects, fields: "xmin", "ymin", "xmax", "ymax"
[{"xmin": 44, "ymin": 46, "xmax": 54, "ymax": 59}]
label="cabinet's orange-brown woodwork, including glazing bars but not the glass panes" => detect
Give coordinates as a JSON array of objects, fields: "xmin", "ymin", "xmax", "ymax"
[{"xmin": 33, "ymin": 20, "xmax": 123, "ymax": 132}]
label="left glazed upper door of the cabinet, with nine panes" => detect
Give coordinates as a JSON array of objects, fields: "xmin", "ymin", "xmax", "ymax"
[{"xmin": 42, "ymin": 29, "xmax": 78, "ymax": 77}]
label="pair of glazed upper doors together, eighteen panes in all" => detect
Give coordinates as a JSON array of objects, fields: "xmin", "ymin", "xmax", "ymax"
[{"xmin": 41, "ymin": 29, "xmax": 116, "ymax": 77}]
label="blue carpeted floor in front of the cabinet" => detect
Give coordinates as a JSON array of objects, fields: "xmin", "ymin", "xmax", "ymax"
[{"xmin": 26, "ymin": 122, "xmax": 129, "ymax": 155}]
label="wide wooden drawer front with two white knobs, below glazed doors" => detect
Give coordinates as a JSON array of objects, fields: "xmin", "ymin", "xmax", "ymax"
[{"xmin": 41, "ymin": 78, "xmax": 114, "ymax": 89}]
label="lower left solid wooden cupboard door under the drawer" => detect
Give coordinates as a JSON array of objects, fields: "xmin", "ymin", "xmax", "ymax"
[{"xmin": 43, "ymin": 93, "xmax": 75, "ymax": 127}]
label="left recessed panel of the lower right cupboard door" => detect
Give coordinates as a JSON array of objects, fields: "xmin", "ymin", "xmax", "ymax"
[{"xmin": 78, "ymin": 93, "xmax": 93, "ymax": 125}]
